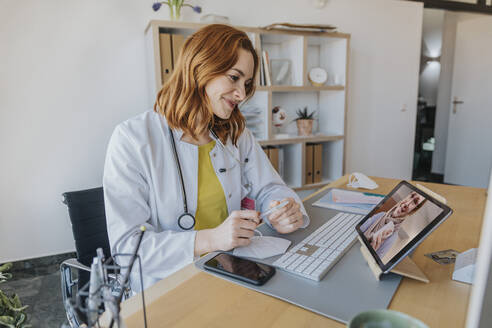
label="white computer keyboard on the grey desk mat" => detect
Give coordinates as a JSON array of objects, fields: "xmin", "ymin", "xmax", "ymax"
[{"xmin": 273, "ymin": 212, "xmax": 364, "ymax": 281}]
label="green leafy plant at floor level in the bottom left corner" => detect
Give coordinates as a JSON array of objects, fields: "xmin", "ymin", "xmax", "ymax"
[{"xmin": 0, "ymin": 263, "xmax": 31, "ymax": 328}]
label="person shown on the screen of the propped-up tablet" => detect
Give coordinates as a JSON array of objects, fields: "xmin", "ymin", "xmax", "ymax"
[{"xmin": 361, "ymin": 191, "xmax": 425, "ymax": 258}]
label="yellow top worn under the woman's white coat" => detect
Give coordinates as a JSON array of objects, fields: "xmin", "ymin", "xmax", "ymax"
[{"xmin": 195, "ymin": 140, "xmax": 229, "ymax": 230}]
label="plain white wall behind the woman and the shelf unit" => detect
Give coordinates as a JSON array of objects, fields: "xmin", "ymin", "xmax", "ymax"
[{"xmin": 0, "ymin": 0, "xmax": 422, "ymax": 262}]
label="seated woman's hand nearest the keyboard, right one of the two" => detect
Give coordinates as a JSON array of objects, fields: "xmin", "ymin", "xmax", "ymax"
[{"xmin": 268, "ymin": 198, "xmax": 304, "ymax": 233}]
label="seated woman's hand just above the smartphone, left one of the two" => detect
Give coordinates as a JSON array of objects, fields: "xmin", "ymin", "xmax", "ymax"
[{"xmin": 195, "ymin": 210, "xmax": 260, "ymax": 256}]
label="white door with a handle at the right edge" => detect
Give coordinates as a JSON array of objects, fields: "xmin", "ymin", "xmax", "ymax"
[{"xmin": 444, "ymin": 15, "xmax": 492, "ymax": 188}]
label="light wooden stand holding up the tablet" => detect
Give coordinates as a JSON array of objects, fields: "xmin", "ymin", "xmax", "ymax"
[{"xmin": 358, "ymin": 184, "xmax": 446, "ymax": 283}]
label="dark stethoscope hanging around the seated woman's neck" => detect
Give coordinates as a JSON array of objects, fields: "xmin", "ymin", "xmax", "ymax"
[{"xmin": 168, "ymin": 126, "xmax": 250, "ymax": 230}]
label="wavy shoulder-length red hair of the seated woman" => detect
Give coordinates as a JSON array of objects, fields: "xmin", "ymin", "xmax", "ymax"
[{"xmin": 154, "ymin": 24, "xmax": 258, "ymax": 145}]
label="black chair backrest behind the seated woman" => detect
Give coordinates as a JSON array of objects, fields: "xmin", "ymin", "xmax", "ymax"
[{"xmin": 63, "ymin": 187, "xmax": 111, "ymax": 288}]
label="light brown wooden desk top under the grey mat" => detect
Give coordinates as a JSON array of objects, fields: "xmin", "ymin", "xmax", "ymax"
[{"xmin": 113, "ymin": 176, "xmax": 486, "ymax": 328}]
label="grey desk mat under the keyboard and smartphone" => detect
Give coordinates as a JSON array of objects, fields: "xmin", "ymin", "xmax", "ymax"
[{"xmin": 195, "ymin": 190, "xmax": 401, "ymax": 323}]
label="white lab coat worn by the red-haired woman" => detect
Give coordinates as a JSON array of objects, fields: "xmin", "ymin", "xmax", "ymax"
[{"xmin": 103, "ymin": 111, "xmax": 309, "ymax": 291}]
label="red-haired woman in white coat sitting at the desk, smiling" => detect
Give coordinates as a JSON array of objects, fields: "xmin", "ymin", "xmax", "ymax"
[{"xmin": 103, "ymin": 24, "xmax": 309, "ymax": 291}]
